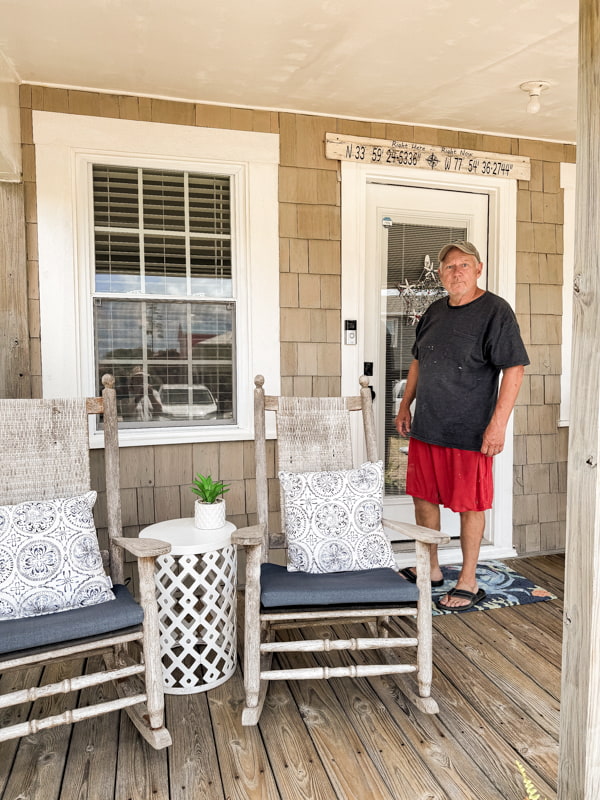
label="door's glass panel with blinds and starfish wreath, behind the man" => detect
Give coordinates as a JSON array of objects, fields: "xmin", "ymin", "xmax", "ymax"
[{"xmin": 382, "ymin": 220, "xmax": 467, "ymax": 497}]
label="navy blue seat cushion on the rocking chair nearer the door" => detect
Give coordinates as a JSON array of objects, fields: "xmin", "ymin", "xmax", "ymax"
[{"xmin": 260, "ymin": 564, "xmax": 419, "ymax": 608}]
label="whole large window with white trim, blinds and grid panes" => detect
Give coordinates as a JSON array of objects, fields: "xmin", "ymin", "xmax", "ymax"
[{"xmin": 34, "ymin": 112, "xmax": 279, "ymax": 446}]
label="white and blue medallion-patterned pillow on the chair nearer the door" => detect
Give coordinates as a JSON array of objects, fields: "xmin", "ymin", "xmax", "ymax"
[{"xmin": 279, "ymin": 461, "xmax": 396, "ymax": 573}]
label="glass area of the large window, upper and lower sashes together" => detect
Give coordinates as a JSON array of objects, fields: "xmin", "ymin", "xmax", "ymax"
[{"xmin": 93, "ymin": 165, "xmax": 236, "ymax": 427}]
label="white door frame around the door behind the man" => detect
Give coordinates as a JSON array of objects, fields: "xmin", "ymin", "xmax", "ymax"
[{"xmin": 341, "ymin": 161, "xmax": 517, "ymax": 566}]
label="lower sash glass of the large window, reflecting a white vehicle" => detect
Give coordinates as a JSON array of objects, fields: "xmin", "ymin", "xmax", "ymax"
[{"xmin": 94, "ymin": 298, "xmax": 235, "ymax": 427}]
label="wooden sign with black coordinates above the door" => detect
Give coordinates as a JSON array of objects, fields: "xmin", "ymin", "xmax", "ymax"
[{"xmin": 325, "ymin": 133, "xmax": 531, "ymax": 181}]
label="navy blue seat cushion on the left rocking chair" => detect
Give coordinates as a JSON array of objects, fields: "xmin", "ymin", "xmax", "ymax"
[{"xmin": 0, "ymin": 585, "xmax": 144, "ymax": 653}]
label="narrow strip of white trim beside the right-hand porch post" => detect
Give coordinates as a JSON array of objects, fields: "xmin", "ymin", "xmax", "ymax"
[{"xmin": 558, "ymin": 163, "xmax": 576, "ymax": 428}]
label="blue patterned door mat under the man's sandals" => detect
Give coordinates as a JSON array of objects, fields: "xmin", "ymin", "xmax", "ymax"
[{"xmin": 431, "ymin": 561, "xmax": 556, "ymax": 614}]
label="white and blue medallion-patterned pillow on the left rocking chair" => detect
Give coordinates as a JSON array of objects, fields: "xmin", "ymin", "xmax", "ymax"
[{"xmin": 0, "ymin": 492, "xmax": 114, "ymax": 620}]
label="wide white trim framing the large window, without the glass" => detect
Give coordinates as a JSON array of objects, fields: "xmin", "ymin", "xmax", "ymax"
[{"xmin": 33, "ymin": 111, "xmax": 280, "ymax": 447}]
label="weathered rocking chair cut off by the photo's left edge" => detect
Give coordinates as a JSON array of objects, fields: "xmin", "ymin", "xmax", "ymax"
[{"xmin": 0, "ymin": 375, "xmax": 171, "ymax": 749}]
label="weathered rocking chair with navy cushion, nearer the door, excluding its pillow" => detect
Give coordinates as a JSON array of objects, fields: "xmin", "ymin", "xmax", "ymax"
[{"xmin": 234, "ymin": 375, "xmax": 449, "ymax": 725}]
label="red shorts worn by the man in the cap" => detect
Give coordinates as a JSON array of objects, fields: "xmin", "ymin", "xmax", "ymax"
[{"xmin": 406, "ymin": 439, "xmax": 494, "ymax": 511}]
